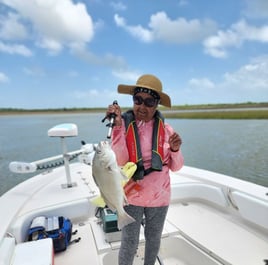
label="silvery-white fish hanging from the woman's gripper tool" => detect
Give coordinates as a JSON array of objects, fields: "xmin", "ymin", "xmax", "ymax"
[{"xmin": 92, "ymin": 141, "xmax": 136, "ymax": 230}]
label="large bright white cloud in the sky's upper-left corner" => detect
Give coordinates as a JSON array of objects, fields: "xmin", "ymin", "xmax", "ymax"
[{"xmin": 0, "ymin": 0, "xmax": 94, "ymax": 53}]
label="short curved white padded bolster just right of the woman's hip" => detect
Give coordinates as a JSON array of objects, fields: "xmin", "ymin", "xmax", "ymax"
[{"xmin": 171, "ymin": 183, "xmax": 229, "ymax": 207}]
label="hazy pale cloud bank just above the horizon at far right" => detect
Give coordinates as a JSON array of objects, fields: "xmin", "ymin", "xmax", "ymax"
[{"xmin": 183, "ymin": 55, "xmax": 268, "ymax": 104}]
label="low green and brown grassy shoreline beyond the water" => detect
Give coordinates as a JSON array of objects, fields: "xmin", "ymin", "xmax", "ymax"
[{"xmin": 0, "ymin": 102, "xmax": 268, "ymax": 119}]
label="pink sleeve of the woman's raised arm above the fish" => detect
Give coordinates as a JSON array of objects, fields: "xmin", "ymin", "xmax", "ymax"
[{"xmin": 111, "ymin": 120, "xmax": 129, "ymax": 166}]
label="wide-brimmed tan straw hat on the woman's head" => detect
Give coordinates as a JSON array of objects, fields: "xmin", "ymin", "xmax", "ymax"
[{"xmin": 117, "ymin": 74, "xmax": 171, "ymax": 108}]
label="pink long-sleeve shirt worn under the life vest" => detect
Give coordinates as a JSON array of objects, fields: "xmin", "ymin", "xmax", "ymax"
[{"xmin": 112, "ymin": 117, "xmax": 184, "ymax": 207}]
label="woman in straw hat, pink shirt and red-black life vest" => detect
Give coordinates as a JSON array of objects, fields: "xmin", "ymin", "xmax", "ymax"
[{"xmin": 107, "ymin": 75, "xmax": 183, "ymax": 265}]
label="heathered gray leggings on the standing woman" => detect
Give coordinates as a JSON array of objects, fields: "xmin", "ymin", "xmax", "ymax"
[{"xmin": 118, "ymin": 205, "xmax": 168, "ymax": 265}]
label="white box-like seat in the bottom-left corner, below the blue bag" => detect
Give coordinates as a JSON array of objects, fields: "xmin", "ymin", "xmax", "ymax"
[{"xmin": 0, "ymin": 237, "xmax": 54, "ymax": 265}]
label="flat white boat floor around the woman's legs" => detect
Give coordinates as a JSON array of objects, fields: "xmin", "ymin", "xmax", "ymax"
[{"xmin": 55, "ymin": 202, "xmax": 268, "ymax": 265}]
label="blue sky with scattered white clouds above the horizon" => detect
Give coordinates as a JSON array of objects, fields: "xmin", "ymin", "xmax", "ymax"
[{"xmin": 0, "ymin": 0, "xmax": 268, "ymax": 109}]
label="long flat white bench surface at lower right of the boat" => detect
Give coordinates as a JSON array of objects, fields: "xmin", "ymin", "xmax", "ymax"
[{"xmin": 167, "ymin": 202, "xmax": 268, "ymax": 265}]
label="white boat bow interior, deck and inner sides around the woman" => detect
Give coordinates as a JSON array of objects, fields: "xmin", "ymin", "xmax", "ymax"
[{"xmin": 2, "ymin": 164, "xmax": 268, "ymax": 265}]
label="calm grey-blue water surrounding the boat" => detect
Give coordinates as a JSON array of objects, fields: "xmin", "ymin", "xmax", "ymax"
[{"xmin": 0, "ymin": 113, "xmax": 268, "ymax": 195}]
